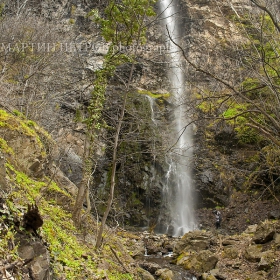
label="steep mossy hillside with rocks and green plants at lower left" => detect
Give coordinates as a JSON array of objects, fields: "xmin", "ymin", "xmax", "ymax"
[{"xmin": 0, "ymin": 109, "xmax": 145, "ymax": 280}]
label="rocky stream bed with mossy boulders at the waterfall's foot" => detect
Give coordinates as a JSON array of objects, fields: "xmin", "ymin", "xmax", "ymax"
[{"xmin": 120, "ymin": 220, "xmax": 280, "ymax": 280}]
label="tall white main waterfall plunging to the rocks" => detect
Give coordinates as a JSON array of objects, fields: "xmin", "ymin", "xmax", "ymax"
[{"xmin": 159, "ymin": 0, "xmax": 195, "ymax": 236}]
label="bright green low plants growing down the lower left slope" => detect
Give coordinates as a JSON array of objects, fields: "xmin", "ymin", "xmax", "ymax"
[{"xmin": 6, "ymin": 164, "xmax": 99, "ymax": 279}]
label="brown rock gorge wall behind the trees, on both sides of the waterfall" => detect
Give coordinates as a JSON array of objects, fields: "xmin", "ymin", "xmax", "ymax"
[{"xmin": 0, "ymin": 0, "xmax": 274, "ymax": 228}]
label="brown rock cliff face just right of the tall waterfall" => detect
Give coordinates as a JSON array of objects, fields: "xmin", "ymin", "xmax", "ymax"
[{"xmin": 176, "ymin": 0, "xmax": 256, "ymax": 208}]
